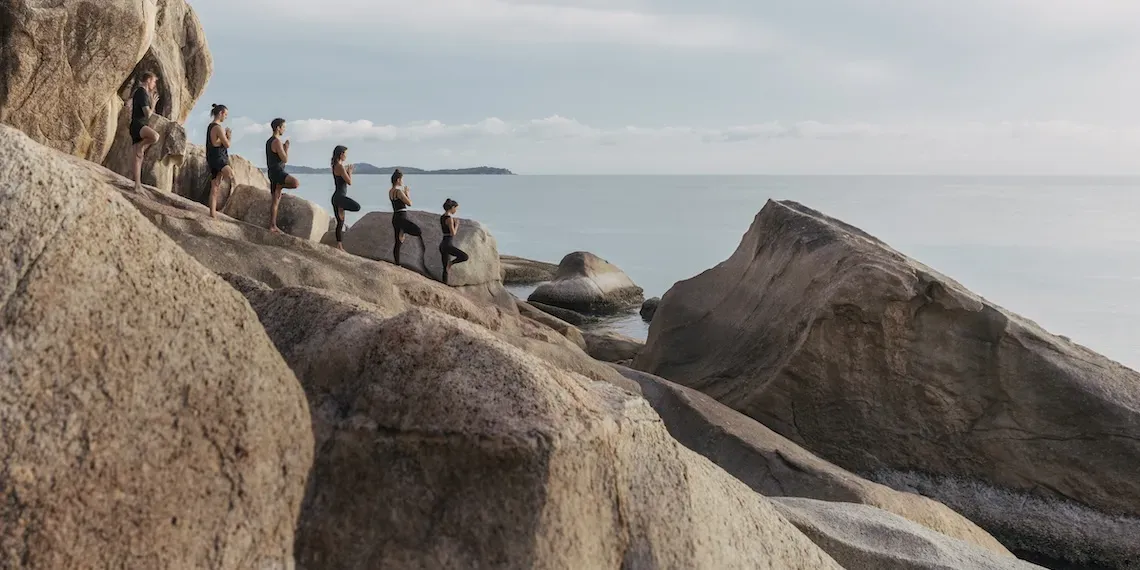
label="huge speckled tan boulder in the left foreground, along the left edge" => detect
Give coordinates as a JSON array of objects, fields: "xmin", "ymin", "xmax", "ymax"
[{"xmin": 0, "ymin": 125, "xmax": 312, "ymax": 570}]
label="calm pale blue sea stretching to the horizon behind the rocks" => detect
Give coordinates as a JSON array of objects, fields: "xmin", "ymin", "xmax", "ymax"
[{"xmin": 287, "ymin": 174, "xmax": 1140, "ymax": 368}]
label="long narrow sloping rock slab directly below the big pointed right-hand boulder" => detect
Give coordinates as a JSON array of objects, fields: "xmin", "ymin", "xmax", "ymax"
[{"xmin": 616, "ymin": 366, "xmax": 1012, "ymax": 557}]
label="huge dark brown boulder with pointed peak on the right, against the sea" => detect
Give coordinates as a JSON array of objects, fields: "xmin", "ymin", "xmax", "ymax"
[{"xmin": 636, "ymin": 202, "xmax": 1140, "ymax": 567}]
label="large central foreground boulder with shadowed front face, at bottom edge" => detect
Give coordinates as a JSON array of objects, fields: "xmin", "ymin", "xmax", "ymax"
[{"xmin": 224, "ymin": 279, "xmax": 839, "ymax": 570}]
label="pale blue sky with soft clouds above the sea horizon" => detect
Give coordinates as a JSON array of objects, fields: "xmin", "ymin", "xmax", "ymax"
[{"xmin": 187, "ymin": 0, "xmax": 1140, "ymax": 174}]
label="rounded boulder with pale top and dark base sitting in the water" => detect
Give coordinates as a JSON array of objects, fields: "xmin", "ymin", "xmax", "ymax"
[{"xmin": 528, "ymin": 252, "xmax": 644, "ymax": 315}]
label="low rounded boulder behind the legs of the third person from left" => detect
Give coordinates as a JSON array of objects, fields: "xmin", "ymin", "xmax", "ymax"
[{"xmin": 222, "ymin": 186, "xmax": 331, "ymax": 242}]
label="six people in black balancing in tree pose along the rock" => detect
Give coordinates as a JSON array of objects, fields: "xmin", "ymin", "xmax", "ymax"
[{"xmin": 129, "ymin": 72, "xmax": 470, "ymax": 284}]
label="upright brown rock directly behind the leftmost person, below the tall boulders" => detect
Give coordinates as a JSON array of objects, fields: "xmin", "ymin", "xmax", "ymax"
[{"xmin": 103, "ymin": 108, "xmax": 187, "ymax": 192}]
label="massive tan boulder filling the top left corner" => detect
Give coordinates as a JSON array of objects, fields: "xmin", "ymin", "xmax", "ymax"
[{"xmin": 0, "ymin": 0, "xmax": 156, "ymax": 162}]
